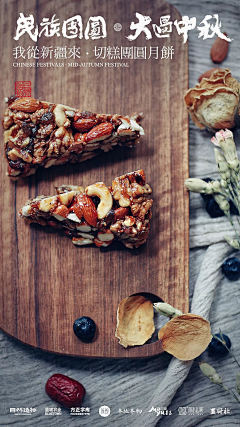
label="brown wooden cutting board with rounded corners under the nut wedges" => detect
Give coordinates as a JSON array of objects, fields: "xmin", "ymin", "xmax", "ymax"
[{"xmin": 0, "ymin": 0, "xmax": 189, "ymax": 357}]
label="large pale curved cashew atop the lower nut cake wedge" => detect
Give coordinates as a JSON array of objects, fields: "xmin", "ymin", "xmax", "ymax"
[{"xmin": 85, "ymin": 182, "xmax": 113, "ymax": 219}]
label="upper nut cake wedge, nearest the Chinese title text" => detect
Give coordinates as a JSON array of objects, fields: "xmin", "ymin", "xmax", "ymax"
[{"xmin": 2, "ymin": 96, "xmax": 144, "ymax": 179}]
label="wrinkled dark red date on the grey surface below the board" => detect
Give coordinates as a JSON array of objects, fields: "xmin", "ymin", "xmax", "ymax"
[{"xmin": 45, "ymin": 374, "xmax": 86, "ymax": 408}]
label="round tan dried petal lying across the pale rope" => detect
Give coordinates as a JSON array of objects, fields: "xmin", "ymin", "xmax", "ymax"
[{"xmin": 158, "ymin": 313, "xmax": 212, "ymax": 360}]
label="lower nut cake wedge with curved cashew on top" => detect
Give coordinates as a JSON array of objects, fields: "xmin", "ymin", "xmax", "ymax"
[{"xmin": 19, "ymin": 170, "xmax": 153, "ymax": 249}]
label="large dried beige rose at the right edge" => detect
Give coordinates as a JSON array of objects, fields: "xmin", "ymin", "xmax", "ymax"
[{"xmin": 184, "ymin": 69, "xmax": 240, "ymax": 130}]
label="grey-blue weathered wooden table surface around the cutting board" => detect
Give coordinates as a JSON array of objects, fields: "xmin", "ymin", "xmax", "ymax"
[{"xmin": 0, "ymin": 0, "xmax": 240, "ymax": 427}]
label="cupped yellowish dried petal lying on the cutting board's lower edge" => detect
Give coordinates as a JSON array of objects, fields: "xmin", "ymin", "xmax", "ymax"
[{"xmin": 115, "ymin": 295, "xmax": 155, "ymax": 347}]
